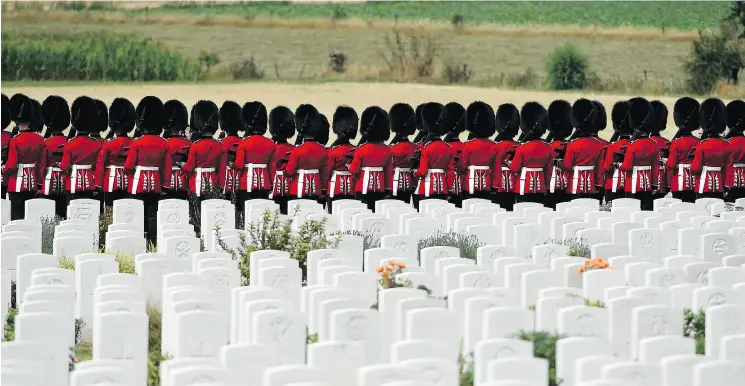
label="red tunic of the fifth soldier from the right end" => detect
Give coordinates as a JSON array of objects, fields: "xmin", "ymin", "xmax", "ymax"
[{"xmin": 620, "ymin": 138, "xmax": 660, "ymax": 193}]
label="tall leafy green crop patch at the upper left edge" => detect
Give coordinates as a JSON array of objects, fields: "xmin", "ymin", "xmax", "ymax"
[{"xmin": 2, "ymin": 31, "xmax": 203, "ymax": 81}]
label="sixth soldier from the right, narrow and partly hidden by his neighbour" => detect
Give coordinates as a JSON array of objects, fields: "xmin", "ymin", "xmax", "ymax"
[{"xmin": 603, "ymin": 101, "xmax": 632, "ymax": 202}]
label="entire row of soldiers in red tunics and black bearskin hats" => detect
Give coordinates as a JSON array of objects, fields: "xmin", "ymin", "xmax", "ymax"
[{"xmin": 2, "ymin": 94, "xmax": 745, "ymax": 241}]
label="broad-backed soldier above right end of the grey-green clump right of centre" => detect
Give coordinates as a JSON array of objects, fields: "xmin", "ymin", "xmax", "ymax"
[{"xmin": 458, "ymin": 101, "xmax": 499, "ymax": 200}]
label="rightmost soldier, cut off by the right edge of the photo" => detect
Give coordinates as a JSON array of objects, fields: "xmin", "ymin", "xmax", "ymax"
[{"xmin": 725, "ymin": 99, "xmax": 745, "ymax": 202}]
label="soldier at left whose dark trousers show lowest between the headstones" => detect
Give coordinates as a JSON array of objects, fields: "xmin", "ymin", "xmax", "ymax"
[{"xmin": 124, "ymin": 96, "xmax": 172, "ymax": 244}]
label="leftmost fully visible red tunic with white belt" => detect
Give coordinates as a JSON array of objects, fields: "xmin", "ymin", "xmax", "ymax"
[{"xmin": 2, "ymin": 131, "xmax": 47, "ymax": 193}]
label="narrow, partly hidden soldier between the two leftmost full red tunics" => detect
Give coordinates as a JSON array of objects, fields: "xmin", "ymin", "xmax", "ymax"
[{"xmin": 41, "ymin": 95, "xmax": 70, "ymax": 218}]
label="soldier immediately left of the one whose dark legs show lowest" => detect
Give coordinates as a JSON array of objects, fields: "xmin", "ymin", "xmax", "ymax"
[{"xmin": 96, "ymin": 98, "xmax": 136, "ymax": 207}]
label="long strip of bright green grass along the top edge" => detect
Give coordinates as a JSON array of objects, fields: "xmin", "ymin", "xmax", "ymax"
[{"xmin": 135, "ymin": 1, "xmax": 730, "ymax": 31}]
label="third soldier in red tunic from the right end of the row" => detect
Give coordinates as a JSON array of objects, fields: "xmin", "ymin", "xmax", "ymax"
[{"xmin": 665, "ymin": 97, "xmax": 700, "ymax": 202}]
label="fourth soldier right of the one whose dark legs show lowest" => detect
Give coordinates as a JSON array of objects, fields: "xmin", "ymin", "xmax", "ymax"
[{"xmin": 235, "ymin": 102, "xmax": 274, "ymax": 204}]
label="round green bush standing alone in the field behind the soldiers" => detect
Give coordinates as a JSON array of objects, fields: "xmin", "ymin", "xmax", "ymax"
[{"xmin": 546, "ymin": 44, "xmax": 590, "ymax": 90}]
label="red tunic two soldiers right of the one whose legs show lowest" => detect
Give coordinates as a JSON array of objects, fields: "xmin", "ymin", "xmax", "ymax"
[{"xmin": 184, "ymin": 137, "xmax": 224, "ymax": 196}]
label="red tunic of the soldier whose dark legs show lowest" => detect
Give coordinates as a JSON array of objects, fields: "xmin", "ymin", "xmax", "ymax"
[{"xmin": 124, "ymin": 134, "xmax": 173, "ymax": 194}]
